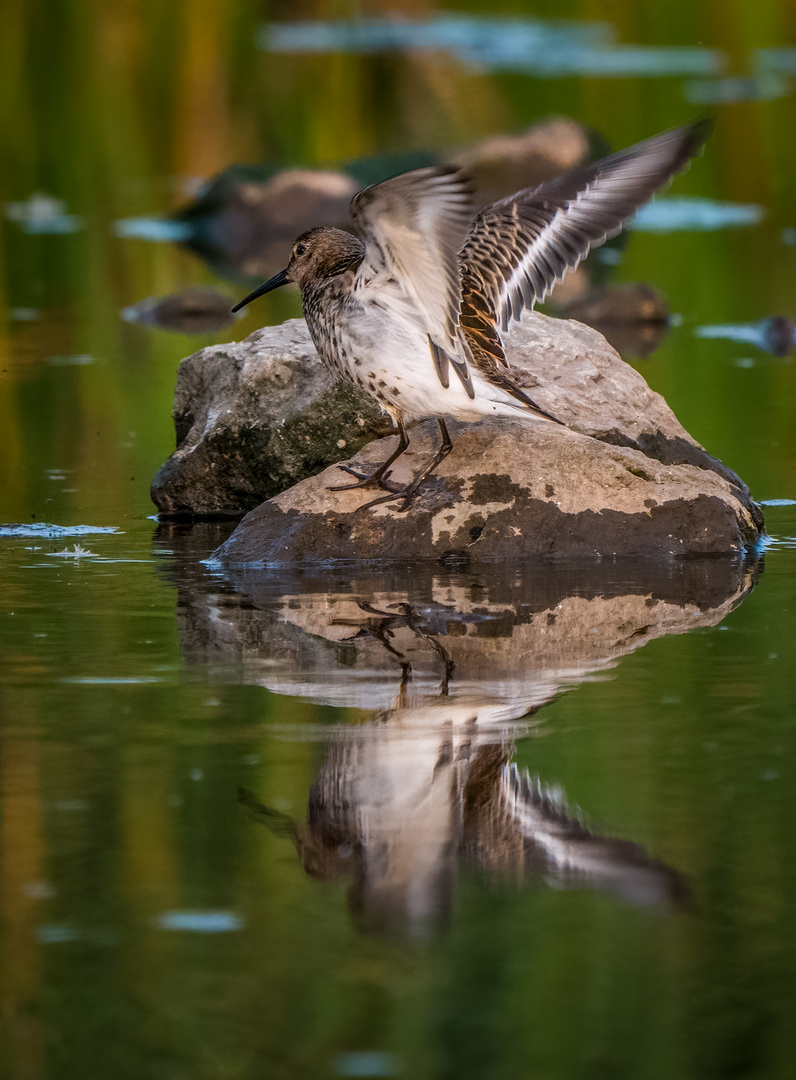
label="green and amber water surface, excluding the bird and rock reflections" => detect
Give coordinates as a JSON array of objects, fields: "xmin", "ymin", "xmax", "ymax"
[{"xmin": 0, "ymin": 0, "xmax": 796, "ymax": 1080}]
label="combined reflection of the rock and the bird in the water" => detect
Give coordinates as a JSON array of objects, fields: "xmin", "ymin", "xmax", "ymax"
[{"xmin": 169, "ymin": 559, "xmax": 756, "ymax": 935}]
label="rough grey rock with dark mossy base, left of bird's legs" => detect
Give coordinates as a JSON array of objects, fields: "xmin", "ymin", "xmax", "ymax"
[{"xmin": 151, "ymin": 319, "xmax": 391, "ymax": 517}]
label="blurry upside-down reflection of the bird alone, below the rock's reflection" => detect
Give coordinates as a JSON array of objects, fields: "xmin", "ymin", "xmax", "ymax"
[{"xmin": 240, "ymin": 741, "xmax": 688, "ymax": 936}]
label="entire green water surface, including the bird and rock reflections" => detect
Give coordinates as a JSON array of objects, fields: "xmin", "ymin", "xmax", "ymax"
[{"xmin": 0, "ymin": 0, "xmax": 796, "ymax": 1080}]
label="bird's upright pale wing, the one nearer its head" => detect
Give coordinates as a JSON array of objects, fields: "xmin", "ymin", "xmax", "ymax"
[{"xmin": 351, "ymin": 166, "xmax": 473, "ymax": 351}]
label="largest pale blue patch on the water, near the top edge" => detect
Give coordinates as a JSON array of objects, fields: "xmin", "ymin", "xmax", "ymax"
[{"xmin": 258, "ymin": 15, "xmax": 725, "ymax": 78}]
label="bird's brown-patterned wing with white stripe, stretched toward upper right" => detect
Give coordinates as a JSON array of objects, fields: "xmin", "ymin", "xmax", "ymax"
[{"xmin": 460, "ymin": 120, "xmax": 712, "ymax": 363}]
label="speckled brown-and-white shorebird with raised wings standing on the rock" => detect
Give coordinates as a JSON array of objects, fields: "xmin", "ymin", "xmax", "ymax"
[{"xmin": 232, "ymin": 120, "xmax": 711, "ymax": 510}]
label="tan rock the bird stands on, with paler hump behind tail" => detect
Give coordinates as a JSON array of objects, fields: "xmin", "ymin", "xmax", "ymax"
[{"xmin": 209, "ymin": 313, "xmax": 764, "ymax": 564}]
